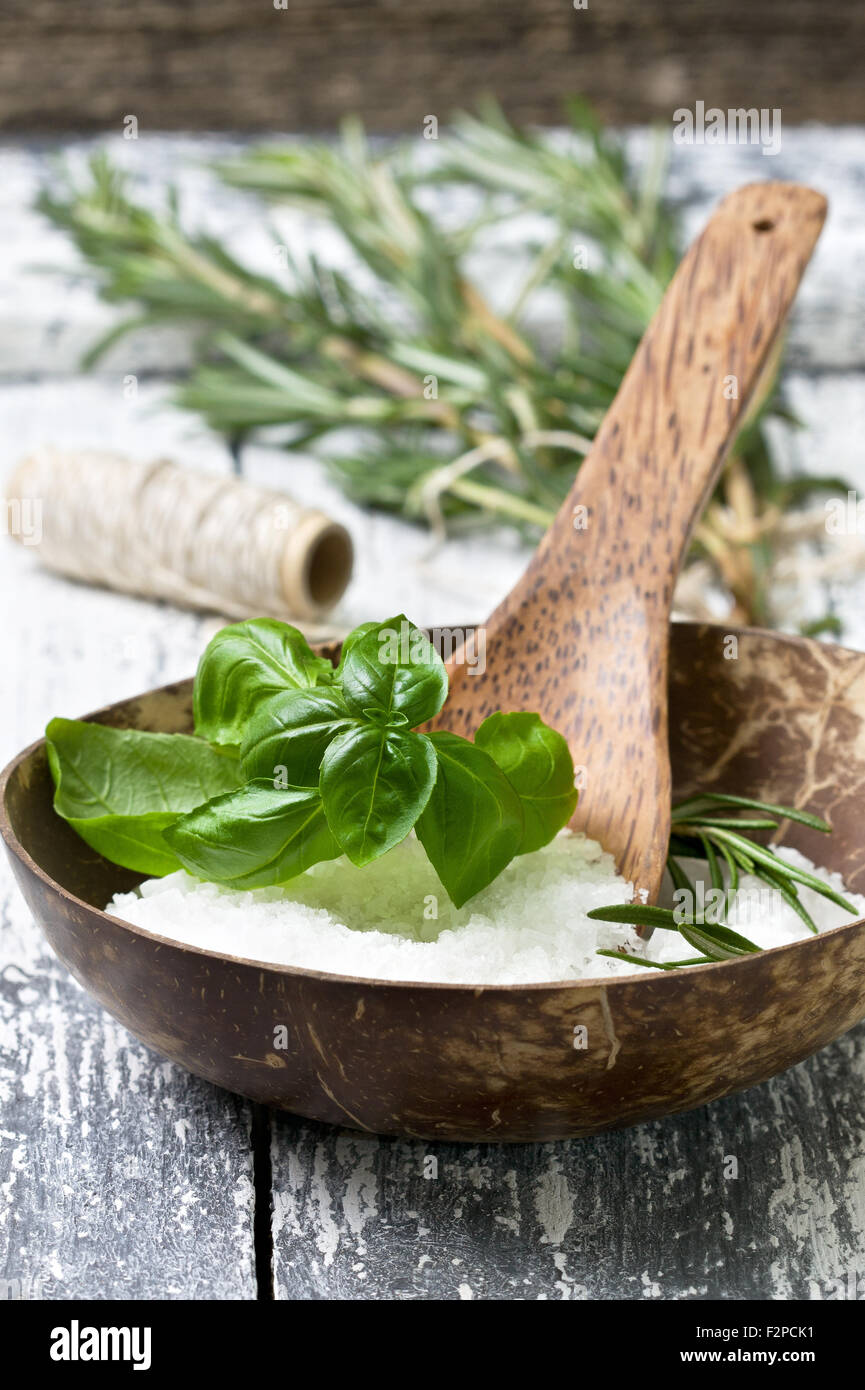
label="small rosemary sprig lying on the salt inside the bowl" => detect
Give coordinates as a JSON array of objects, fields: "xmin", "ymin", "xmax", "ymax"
[{"xmin": 588, "ymin": 792, "xmax": 857, "ymax": 970}]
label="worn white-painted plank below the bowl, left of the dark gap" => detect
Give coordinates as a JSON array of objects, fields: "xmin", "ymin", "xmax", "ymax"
[{"xmin": 0, "ymin": 889, "xmax": 256, "ymax": 1300}]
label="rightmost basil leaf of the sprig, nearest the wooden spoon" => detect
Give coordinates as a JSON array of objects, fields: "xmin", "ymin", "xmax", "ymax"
[{"xmin": 474, "ymin": 710, "xmax": 579, "ymax": 855}]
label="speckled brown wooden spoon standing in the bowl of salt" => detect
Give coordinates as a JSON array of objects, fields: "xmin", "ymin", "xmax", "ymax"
[{"xmin": 437, "ymin": 183, "xmax": 826, "ymax": 902}]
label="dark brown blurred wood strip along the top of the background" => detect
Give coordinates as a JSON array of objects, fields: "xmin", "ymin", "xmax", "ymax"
[{"xmin": 0, "ymin": 0, "xmax": 865, "ymax": 131}]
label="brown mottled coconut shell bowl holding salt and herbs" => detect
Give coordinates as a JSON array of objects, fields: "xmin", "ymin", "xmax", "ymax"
[{"xmin": 0, "ymin": 624, "xmax": 865, "ymax": 1141}]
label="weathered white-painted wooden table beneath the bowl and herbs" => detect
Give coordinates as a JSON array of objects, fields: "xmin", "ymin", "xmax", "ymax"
[{"xmin": 0, "ymin": 131, "xmax": 865, "ymax": 1300}]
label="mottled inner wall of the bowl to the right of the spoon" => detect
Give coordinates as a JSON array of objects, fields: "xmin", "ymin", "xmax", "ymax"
[{"xmin": 669, "ymin": 623, "xmax": 865, "ymax": 892}]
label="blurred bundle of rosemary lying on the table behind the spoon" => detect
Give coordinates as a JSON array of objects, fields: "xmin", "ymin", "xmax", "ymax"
[{"xmin": 39, "ymin": 101, "xmax": 834, "ymax": 621}]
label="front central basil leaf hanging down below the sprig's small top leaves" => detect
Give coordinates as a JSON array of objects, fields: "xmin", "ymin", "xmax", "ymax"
[{"xmin": 321, "ymin": 724, "xmax": 435, "ymax": 866}]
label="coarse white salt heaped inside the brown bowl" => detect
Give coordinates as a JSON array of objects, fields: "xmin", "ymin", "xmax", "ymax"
[{"xmin": 106, "ymin": 831, "xmax": 865, "ymax": 984}]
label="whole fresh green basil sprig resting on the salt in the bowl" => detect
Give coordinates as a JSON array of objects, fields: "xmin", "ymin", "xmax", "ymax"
[{"xmin": 49, "ymin": 614, "xmax": 577, "ymax": 906}]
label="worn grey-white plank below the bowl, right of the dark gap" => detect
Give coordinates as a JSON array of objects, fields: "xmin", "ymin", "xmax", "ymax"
[{"xmin": 271, "ymin": 1026, "xmax": 865, "ymax": 1300}]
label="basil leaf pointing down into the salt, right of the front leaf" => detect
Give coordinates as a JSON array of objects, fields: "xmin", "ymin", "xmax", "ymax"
[{"xmin": 416, "ymin": 733, "xmax": 526, "ymax": 908}]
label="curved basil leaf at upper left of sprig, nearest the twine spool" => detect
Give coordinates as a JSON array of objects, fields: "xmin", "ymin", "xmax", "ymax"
[{"xmin": 193, "ymin": 617, "xmax": 334, "ymax": 744}]
